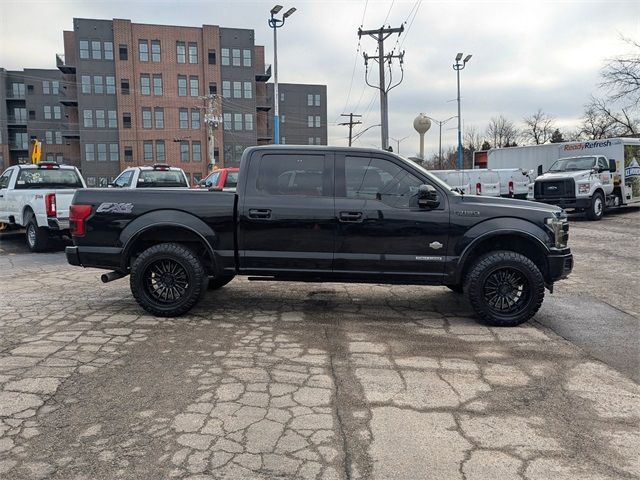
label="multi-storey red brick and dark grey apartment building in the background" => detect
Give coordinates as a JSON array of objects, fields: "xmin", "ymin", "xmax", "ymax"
[{"xmin": 0, "ymin": 18, "xmax": 327, "ymax": 186}]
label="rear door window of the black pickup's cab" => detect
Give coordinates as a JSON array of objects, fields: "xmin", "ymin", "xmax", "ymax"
[{"xmin": 255, "ymin": 154, "xmax": 328, "ymax": 197}]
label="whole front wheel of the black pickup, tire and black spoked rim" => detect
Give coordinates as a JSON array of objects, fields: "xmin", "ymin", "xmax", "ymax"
[{"xmin": 464, "ymin": 250, "xmax": 544, "ymax": 327}]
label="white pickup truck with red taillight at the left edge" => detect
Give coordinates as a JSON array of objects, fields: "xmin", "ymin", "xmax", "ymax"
[{"xmin": 0, "ymin": 162, "xmax": 86, "ymax": 252}]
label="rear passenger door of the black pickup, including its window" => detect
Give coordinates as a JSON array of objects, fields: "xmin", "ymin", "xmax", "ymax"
[{"xmin": 238, "ymin": 149, "xmax": 336, "ymax": 275}]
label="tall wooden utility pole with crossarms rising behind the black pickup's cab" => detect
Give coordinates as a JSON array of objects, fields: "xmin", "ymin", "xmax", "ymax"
[{"xmin": 358, "ymin": 25, "xmax": 404, "ymax": 150}]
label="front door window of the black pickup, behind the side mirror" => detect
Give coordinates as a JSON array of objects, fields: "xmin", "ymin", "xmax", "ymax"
[{"xmin": 345, "ymin": 157, "xmax": 424, "ymax": 208}]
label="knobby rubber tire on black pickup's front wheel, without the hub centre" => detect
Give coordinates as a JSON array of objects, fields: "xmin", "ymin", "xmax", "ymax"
[{"xmin": 464, "ymin": 250, "xmax": 544, "ymax": 327}]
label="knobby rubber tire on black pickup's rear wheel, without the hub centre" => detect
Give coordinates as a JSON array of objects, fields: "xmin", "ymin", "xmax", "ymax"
[{"xmin": 129, "ymin": 243, "xmax": 208, "ymax": 317}]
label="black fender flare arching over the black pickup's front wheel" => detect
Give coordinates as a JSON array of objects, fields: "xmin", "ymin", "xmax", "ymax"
[{"xmin": 454, "ymin": 217, "xmax": 551, "ymax": 283}]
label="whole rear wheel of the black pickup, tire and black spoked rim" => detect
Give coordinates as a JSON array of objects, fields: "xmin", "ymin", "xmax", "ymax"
[{"xmin": 130, "ymin": 243, "xmax": 208, "ymax": 317}]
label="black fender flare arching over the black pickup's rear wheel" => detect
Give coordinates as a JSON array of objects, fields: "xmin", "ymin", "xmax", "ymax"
[{"xmin": 120, "ymin": 209, "xmax": 218, "ymax": 273}]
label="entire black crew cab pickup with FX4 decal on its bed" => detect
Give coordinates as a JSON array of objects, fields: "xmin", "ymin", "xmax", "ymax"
[{"xmin": 66, "ymin": 146, "xmax": 573, "ymax": 326}]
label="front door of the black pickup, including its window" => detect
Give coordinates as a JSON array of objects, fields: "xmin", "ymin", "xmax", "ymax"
[{"xmin": 334, "ymin": 153, "xmax": 449, "ymax": 280}]
